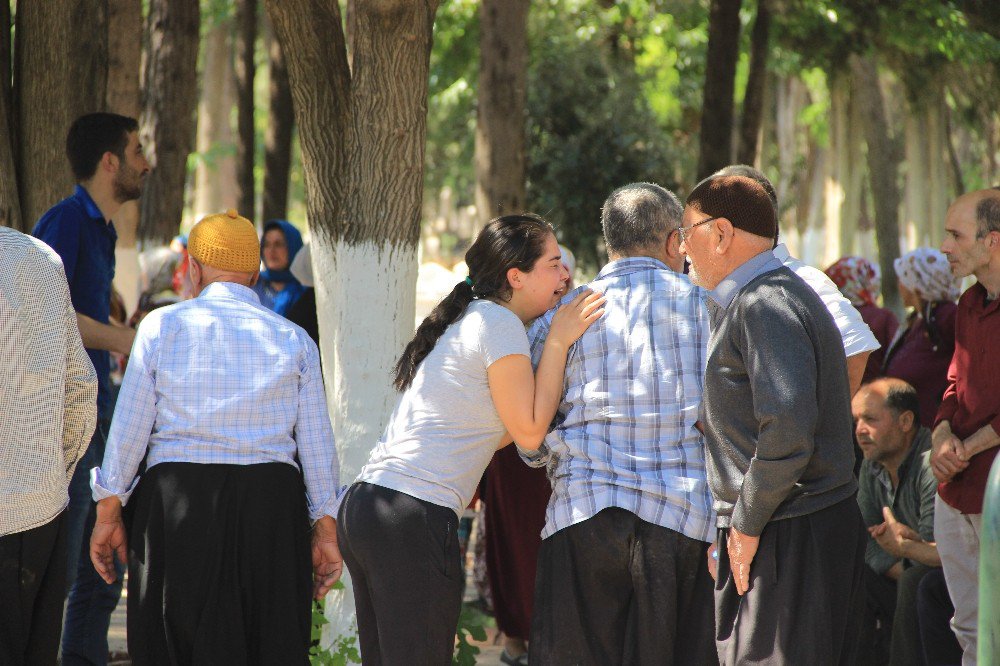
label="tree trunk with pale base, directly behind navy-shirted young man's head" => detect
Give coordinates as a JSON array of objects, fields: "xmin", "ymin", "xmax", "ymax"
[{"xmin": 106, "ymin": 0, "xmax": 142, "ymax": 313}]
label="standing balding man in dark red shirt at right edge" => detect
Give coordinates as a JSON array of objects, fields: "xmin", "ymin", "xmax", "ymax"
[{"xmin": 931, "ymin": 188, "xmax": 1000, "ymax": 665}]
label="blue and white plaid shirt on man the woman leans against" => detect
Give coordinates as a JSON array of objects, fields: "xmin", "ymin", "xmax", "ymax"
[{"xmin": 521, "ymin": 257, "xmax": 715, "ymax": 541}]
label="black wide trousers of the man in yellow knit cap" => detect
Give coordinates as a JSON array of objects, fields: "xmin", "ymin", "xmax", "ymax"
[{"xmin": 126, "ymin": 463, "xmax": 312, "ymax": 666}]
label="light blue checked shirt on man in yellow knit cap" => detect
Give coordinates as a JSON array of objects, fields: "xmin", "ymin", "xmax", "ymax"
[{"xmin": 91, "ymin": 282, "xmax": 340, "ymax": 520}]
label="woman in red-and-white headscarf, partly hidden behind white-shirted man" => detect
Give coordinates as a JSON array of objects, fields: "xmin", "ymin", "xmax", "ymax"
[{"xmin": 825, "ymin": 257, "xmax": 899, "ymax": 384}]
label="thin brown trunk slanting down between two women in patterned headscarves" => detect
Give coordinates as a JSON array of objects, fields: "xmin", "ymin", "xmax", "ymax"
[{"xmin": 851, "ymin": 56, "xmax": 902, "ymax": 314}]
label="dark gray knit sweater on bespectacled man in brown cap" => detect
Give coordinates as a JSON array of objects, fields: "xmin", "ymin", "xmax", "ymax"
[{"xmin": 704, "ymin": 267, "xmax": 857, "ymax": 535}]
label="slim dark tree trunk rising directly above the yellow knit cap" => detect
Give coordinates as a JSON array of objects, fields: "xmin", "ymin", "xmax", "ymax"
[{"xmin": 236, "ymin": 0, "xmax": 257, "ymax": 220}]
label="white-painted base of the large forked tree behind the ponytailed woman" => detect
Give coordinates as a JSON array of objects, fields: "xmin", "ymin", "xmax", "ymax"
[{"xmin": 312, "ymin": 233, "xmax": 417, "ymax": 646}]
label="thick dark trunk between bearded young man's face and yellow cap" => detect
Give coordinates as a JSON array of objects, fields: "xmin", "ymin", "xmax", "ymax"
[{"xmin": 139, "ymin": 0, "xmax": 200, "ymax": 246}]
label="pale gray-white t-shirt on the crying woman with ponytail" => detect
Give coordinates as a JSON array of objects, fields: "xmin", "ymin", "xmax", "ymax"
[{"xmin": 358, "ymin": 300, "xmax": 531, "ymax": 515}]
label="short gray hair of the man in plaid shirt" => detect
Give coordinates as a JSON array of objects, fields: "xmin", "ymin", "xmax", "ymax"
[{"xmin": 601, "ymin": 183, "xmax": 684, "ymax": 256}]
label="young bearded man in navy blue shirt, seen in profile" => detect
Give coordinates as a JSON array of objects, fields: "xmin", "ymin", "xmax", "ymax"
[{"xmin": 32, "ymin": 113, "xmax": 150, "ymax": 665}]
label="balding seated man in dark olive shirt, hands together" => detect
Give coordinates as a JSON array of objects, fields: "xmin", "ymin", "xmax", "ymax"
[{"xmin": 851, "ymin": 378, "xmax": 941, "ymax": 664}]
